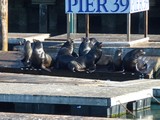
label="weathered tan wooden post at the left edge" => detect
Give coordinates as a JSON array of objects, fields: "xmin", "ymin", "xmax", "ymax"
[{"xmin": 0, "ymin": 0, "xmax": 8, "ymax": 51}]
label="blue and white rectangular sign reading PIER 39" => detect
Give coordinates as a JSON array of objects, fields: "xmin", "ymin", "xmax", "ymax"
[{"xmin": 65, "ymin": 0, "xmax": 149, "ymax": 14}]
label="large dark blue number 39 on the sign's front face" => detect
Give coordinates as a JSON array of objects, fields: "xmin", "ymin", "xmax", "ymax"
[{"xmin": 111, "ymin": 0, "xmax": 129, "ymax": 12}]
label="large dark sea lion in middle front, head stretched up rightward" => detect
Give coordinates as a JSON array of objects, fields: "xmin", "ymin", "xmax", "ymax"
[{"xmin": 68, "ymin": 42, "xmax": 102, "ymax": 73}]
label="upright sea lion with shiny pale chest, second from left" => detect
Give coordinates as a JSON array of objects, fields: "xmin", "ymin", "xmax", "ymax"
[{"xmin": 31, "ymin": 40, "xmax": 54, "ymax": 72}]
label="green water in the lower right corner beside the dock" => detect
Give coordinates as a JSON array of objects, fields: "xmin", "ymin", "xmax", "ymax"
[{"xmin": 119, "ymin": 104, "xmax": 160, "ymax": 120}]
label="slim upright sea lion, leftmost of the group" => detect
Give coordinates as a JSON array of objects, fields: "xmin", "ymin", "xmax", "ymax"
[{"xmin": 21, "ymin": 41, "xmax": 32, "ymax": 67}]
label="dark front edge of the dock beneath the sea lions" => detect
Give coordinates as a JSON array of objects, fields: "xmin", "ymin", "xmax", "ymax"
[{"xmin": 0, "ymin": 68, "xmax": 150, "ymax": 81}]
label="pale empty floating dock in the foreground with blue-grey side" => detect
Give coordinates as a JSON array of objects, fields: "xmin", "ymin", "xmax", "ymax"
[{"xmin": 0, "ymin": 73, "xmax": 160, "ymax": 117}]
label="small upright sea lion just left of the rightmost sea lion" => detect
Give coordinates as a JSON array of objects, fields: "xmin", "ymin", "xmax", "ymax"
[{"xmin": 113, "ymin": 49, "xmax": 123, "ymax": 71}]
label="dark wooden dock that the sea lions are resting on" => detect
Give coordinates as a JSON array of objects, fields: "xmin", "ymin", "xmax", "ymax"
[{"xmin": 0, "ymin": 51, "xmax": 155, "ymax": 81}]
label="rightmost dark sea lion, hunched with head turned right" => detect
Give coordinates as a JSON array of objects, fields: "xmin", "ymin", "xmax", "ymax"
[{"xmin": 123, "ymin": 49, "xmax": 146, "ymax": 72}]
